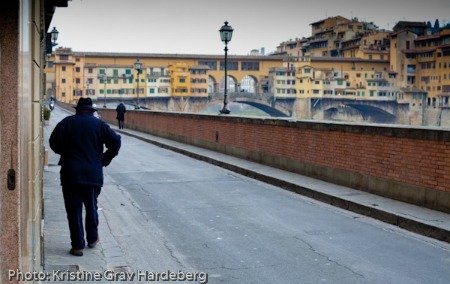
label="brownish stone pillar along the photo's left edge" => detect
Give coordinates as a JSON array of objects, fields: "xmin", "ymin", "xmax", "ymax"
[{"xmin": 0, "ymin": 1, "xmax": 20, "ymax": 283}]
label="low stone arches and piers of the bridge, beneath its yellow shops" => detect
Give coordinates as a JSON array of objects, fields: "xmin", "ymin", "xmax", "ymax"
[{"xmin": 97, "ymin": 92, "xmax": 409, "ymax": 123}]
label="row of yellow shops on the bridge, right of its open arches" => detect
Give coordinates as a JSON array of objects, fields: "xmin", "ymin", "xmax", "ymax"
[{"xmin": 270, "ymin": 57, "xmax": 399, "ymax": 100}]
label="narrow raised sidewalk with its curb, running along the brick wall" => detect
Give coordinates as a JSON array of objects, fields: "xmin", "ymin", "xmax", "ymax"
[{"xmin": 112, "ymin": 126, "xmax": 450, "ymax": 243}]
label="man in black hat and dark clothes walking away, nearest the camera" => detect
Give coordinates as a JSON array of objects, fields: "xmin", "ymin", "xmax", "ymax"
[{"xmin": 50, "ymin": 98, "xmax": 121, "ymax": 256}]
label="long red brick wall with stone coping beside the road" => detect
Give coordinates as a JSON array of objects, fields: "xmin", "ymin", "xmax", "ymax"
[{"xmin": 96, "ymin": 110, "xmax": 450, "ymax": 212}]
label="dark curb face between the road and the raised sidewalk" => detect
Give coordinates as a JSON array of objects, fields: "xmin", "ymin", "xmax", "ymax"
[{"xmin": 115, "ymin": 129, "xmax": 450, "ymax": 243}]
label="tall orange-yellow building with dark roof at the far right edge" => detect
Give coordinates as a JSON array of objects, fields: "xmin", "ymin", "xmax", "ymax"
[{"xmin": 390, "ymin": 22, "xmax": 450, "ymax": 107}]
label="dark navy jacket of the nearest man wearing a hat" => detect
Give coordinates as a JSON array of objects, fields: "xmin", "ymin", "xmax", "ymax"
[{"xmin": 50, "ymin": 112, "xmax": 121, "ymax": 186}]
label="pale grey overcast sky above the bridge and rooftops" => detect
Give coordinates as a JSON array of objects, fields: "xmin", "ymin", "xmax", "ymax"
[{"xmin": 50, "ymin": 0, "xmax": 450, "ymax": 55}]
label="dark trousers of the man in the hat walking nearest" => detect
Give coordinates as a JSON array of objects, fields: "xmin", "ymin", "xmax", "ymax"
[{"xmin": 63, "ymin": 185, "xmax": 101, "ymax": 249}]
